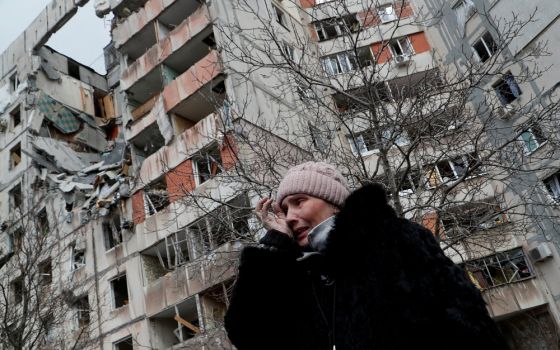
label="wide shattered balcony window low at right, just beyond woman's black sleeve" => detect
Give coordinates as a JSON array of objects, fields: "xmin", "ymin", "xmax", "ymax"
[{"xmin": 464, "ymin": 248, "xmax": 534, "ymax": 289}]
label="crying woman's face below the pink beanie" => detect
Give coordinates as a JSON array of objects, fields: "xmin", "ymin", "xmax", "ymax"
[{"xmin": 282, "ymin": 193, "xmax": 338, "ymax": 247}]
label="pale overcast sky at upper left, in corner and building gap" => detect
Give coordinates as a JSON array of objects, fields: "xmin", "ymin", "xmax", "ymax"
[{"xmin": 0, "ymin": 0, "xmax": 111, "ymax": 74}]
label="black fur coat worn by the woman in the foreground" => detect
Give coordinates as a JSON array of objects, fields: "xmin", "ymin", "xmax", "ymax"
[{"xmin": 225, "ymin": 185, "xmax": 506, "ymax": 350}]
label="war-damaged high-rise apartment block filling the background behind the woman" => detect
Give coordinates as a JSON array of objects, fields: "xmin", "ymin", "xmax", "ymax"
[{"xmin": 0, "ymin": 0, "xmax": 560, "ymax": 350}]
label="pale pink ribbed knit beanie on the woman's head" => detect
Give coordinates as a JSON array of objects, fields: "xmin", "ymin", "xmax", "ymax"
[{"xmin": 276, "ymin": 162, "xmax": 350, "ymax": 207}]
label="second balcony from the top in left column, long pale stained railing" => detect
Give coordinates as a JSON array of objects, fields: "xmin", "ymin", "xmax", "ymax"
[{"xmin": 121, "ymin": 6, "xmax": 212, "ymax": 103}]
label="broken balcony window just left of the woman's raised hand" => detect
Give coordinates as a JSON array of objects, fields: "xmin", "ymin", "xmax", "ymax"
[{"xmin": 187, "ymin": 195, "xmax": 251, "ymax": 257}]
